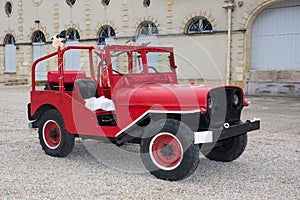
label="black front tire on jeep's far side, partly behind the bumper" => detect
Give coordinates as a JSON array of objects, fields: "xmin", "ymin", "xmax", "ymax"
[{"xmin": 201, "ymin": 133, "xmax": 247, "ymax": 162}]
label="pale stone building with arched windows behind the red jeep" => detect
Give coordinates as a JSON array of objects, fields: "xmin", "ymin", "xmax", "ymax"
[{"xmin": 0, "ymin": 0, "xmax": 300, "ymax": 96}]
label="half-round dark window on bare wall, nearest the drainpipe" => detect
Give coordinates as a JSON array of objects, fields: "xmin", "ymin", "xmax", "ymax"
[{"xmin": 186, "ymin": 17, "xmax": 213, "ymax": 34}]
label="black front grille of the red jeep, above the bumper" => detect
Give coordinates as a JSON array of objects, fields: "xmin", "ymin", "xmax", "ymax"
[{"xmin": 206, "ymin": 87, "xmax": 243, "ymax": 127}]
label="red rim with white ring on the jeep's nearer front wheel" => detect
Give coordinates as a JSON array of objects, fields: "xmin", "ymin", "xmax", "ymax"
[{"xmin": 149, "ymin": 133, "xmax": 183, "ymax": 170}]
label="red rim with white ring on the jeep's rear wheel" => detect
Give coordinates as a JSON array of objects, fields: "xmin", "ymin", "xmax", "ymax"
[{"xmin": 43, "ymin": 120, "xmax": 61, "ymax": 149}]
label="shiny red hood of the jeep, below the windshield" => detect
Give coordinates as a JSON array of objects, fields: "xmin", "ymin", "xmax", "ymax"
[{"xmin": 113, "ymin": 84, "xmax": 224, "ymax": 113}]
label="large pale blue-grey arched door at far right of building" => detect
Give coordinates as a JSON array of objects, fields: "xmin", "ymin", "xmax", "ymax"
[{"xmin": 251, "ymin": 1, "xmax": 300, "ymax": 70}]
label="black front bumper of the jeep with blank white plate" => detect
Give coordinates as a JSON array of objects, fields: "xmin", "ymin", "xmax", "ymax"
[{"xmin": 194, "ymin": 119, "xmax": 260, "ymax": 144}]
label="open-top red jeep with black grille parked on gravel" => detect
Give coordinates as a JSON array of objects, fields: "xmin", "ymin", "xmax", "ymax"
[{"xmin": 28, "ymin": 45, "xmax": 260, "ymax": 181}]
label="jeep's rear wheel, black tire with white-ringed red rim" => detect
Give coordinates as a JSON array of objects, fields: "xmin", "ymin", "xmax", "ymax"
[{"xmin": 39, "ymin": 109, "xmax": 75, "ymax": 157}]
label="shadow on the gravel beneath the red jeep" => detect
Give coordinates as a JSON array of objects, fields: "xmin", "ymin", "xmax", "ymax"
[{"xmin": 67, "ymin": 140, "xmax": 248, "ymax": 183}]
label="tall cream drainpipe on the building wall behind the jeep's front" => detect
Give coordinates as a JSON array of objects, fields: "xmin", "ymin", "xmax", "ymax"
[{"xmin": 223, "ymin": 0, "xmax": 235, "ymax": 85}]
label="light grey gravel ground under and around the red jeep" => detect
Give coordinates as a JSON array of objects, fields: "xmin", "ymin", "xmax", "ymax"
[{"xmin": 0, "ymin": 85, "xmax": 300, "ymax": 199}]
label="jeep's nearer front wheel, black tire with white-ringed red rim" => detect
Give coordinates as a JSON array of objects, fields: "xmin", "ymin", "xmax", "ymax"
[{"xmin": 141, "ymin": 119, "xmax": 199, "ymax": 181}]
